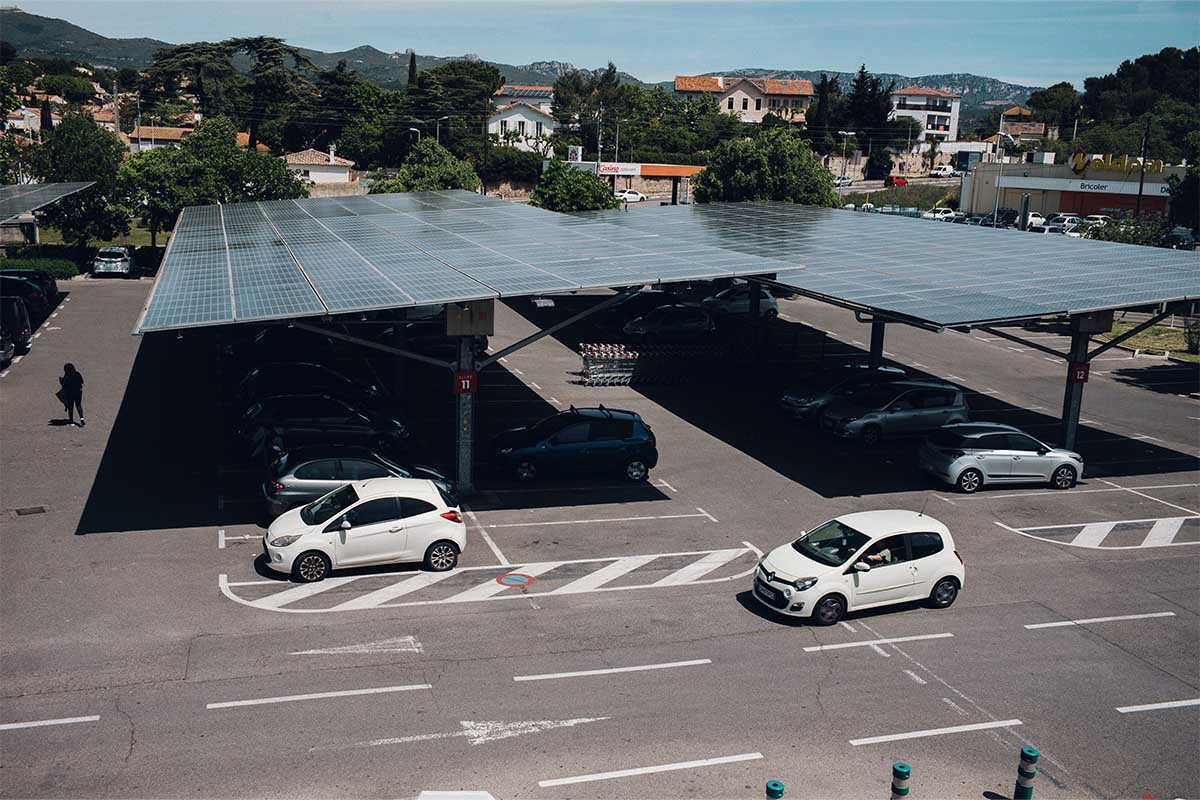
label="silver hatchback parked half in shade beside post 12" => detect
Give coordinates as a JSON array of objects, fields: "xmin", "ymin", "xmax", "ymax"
[{"xmin": 919, "ymin": 422, "xmax": 1084, "ymax": 494}]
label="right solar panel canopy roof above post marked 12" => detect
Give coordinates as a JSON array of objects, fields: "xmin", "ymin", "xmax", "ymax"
[{"xmin": 580, "ymin": 203, "xmax": 1200, "ymax": 325}]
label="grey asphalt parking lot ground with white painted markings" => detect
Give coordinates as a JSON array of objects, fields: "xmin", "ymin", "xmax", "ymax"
[{"xmin": 0, "ymin": 282, "xmax": 1200, "ymax": 798}]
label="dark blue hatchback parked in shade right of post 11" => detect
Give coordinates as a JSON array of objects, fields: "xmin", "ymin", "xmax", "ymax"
[{"xmin": 491, "ymin": 405, "xmax": 659, "ymax": 482}]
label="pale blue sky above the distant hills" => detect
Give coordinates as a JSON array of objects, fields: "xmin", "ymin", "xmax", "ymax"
[{"xmin": 16, "ymin": 0, "xmax": 1200, "ymax": 88}]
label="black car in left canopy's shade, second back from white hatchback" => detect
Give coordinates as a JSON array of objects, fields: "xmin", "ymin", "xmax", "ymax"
[{"xmin": 238, "ymin": 395, "xmax": 410, "ymax": 453}]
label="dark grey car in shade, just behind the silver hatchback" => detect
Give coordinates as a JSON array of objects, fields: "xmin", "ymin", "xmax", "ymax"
[{"xmin": 821, "ymin": 380, "xmax": 971, "ymax": 446}]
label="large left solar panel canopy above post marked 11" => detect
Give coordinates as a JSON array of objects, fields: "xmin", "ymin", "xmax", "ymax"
[{"xmin": 134, "ymin": 191, "xmax": 802, "ymax": 333}]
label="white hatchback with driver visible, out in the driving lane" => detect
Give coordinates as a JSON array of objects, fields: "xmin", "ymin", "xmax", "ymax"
[{"xmin": 754, "ymin": 511, "xmax": 966, "ymax": 625}]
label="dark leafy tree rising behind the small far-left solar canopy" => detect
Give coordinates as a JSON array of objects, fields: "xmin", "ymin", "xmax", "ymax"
[{"xmin": 34, "ymin": 114, "xmax": 130, "ymax": 247}]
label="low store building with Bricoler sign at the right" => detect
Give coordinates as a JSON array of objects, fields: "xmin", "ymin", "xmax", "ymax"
[{"xmin": 962, "ymin": 157, "xmax": 1184, "ymax": 218}]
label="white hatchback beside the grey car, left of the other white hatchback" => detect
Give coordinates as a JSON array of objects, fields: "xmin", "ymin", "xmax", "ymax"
[{"xmin": 263, "ymin": 477, "xmax": 467, "ymax": 583}]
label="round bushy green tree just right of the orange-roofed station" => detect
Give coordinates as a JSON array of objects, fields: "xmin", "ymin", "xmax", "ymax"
[{"xmin": 694, "ymin": 128, "xmax": 838, "ymax": 207}]
